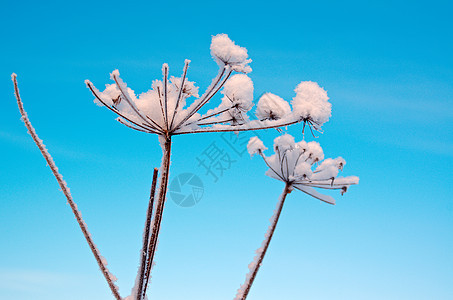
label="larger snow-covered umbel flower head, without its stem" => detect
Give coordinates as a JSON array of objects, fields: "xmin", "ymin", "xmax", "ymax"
[{"xmin": 85, "ymin": 34, "xmax": 331, "ymax": 137}]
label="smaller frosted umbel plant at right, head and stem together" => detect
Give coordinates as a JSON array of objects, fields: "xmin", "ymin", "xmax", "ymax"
[{"xmin": 235, "ymin": 135, "xmax": 359, "ymax": 300}]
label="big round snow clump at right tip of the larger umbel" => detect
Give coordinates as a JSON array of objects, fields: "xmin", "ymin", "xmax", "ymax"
[{"xmin": 291, "ymin": 81, "xmax": 332, "ymax": 129}]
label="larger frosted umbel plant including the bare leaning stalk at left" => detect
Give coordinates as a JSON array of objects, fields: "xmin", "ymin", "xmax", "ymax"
[{"xmin": 13, "ymin": 34, "xmax": 330, "ymax": 300}]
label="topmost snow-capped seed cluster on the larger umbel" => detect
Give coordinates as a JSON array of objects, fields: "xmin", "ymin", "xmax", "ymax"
[{"xmin": 211, "ymin": 34, "xmax": 252, "ymax": 73}]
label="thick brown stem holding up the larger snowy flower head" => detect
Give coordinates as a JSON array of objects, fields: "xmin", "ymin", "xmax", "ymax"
[{"xmin": 142, "ymin": 136, "xmax": 171, "ymax": 297}]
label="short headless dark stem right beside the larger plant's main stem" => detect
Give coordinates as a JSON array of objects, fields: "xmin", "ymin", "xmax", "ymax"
[{"xmin": 136, "ymin": 168, "xmax": 158, "ymax": 300}]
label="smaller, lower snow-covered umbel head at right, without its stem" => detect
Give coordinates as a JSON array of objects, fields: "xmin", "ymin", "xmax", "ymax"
[{"xmin": 247, "ymin": 134, "xmax": 359, "ymax": 204}]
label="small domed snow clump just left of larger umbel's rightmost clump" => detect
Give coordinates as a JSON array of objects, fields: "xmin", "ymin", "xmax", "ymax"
[{"xmin": 256, "ymin": 93, "xmax": 291, "ymax": 120}]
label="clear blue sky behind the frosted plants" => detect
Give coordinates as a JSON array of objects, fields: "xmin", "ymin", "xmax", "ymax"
[{"xmin": 0, "ymin": 1, "xmax": 453, "ymax": 300}]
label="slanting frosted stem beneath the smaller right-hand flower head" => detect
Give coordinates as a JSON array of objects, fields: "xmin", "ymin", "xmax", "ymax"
[{"xmin": 234, "ymin": 183, "xmax": 291, "ymax": 300}]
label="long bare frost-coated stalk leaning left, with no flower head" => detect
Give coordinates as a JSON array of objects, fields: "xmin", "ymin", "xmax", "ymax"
[{"xmin": 11, "ymin": 73, "xmax": 121, "ymax": 300}]
